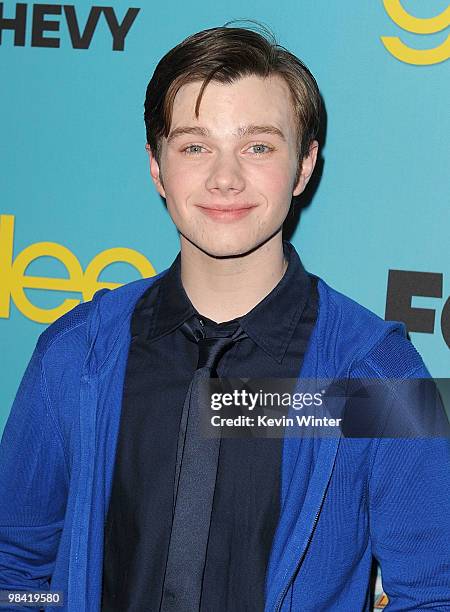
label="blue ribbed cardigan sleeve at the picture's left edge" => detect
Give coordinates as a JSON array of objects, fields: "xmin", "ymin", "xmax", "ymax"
[{"xmin": 0, "ymin": 343, "xmax": 68, "ymax": 611}]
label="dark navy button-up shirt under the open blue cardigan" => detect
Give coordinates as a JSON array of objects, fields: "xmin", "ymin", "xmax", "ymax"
[{"xmin": 102, "ymin": 241, "xmax": 317, "ymax": 612}]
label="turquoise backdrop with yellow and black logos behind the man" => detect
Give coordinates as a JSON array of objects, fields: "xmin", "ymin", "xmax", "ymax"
[{"xmin": 0, "ymin": 0, "xmax": 450, "ymax": 606}]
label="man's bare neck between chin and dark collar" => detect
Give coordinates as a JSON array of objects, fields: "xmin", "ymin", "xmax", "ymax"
[{"xmin": 181, "ymin": 232, "xmax": 287, "ymax": 323}]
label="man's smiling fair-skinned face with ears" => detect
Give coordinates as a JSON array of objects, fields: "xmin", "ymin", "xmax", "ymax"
[{"xmin": 150, "ymin": 75, "xmax": 317, "ymax": 257}]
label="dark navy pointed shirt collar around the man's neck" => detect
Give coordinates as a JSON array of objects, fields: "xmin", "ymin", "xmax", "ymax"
[{"xmin": 136, "ymin": 240, "xmax": 311, "ymax": 363}]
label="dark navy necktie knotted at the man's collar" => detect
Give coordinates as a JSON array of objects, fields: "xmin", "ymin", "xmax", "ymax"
[{"xmin": 160, "ymin": 317, "xmax": 247, "ymax": 612}]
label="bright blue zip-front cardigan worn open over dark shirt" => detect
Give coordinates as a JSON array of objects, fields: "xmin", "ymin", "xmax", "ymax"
[{"xmin": 0, "ymin": 270, "xmax": 450, "ymax": 612}]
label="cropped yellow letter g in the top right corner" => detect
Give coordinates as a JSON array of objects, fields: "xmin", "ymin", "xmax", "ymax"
[{"xmin": 381, "ymin": 0, "xmax": 450, "ymax": 66}]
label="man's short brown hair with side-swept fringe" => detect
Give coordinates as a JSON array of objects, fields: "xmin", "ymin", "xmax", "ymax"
[{"xmin": 144, "ymin": 20, "xmax": 321, "ymax": 173}]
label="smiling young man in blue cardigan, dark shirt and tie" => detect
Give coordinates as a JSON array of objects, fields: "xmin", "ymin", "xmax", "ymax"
[{"xmin": 0, "ymin": 27, "xmax": 450, "ymax": 612}]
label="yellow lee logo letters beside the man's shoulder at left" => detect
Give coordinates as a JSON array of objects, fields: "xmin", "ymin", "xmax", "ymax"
[{"xmin": 0, "ymin": 215, "xmax": 156, "ymax": 323}]
